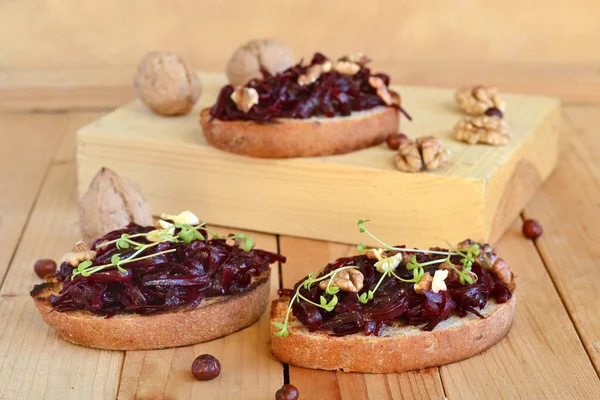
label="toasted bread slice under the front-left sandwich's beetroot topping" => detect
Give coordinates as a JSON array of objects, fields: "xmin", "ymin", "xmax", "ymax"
[{"xmin": 30, "ymin": 270, "xmax": 270, "ymax": 350}]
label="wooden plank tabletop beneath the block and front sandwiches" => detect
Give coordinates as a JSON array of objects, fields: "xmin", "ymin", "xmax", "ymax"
[{"xmin": 0, "ymin": 93, "xmax": 600, "ymax": 400}]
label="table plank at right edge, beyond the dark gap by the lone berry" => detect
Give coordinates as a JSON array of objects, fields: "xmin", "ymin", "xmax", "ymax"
[{"xmin": 525, "ymin": 107, "xmax": 600, "ymax": 373}]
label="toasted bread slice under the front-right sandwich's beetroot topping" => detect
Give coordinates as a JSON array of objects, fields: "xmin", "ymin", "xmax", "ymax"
[{"xmin": 271, "ymin": 293, "xmax": 516, "ymax": 373}]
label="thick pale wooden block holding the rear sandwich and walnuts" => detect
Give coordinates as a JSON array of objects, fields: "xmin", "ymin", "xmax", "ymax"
[{"xmin": 77, "ymin": 73, "xmax": 561, "ymax": 246}]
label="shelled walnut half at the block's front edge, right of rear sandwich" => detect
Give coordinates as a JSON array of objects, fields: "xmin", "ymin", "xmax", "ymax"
[{"xmin": 394, "ymin": 136, "xmax": 450, "ymax": 172}]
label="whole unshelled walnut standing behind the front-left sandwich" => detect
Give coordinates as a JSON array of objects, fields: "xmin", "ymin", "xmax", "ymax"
[{"xmin": 79, "ymin": 168, "xmax": 153, "ymax": 243}]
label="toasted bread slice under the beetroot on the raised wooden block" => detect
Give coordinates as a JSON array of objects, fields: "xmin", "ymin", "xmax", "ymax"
[{"xmin": 200, "ymin": 106, "xmax": 399, "ymax": 158}]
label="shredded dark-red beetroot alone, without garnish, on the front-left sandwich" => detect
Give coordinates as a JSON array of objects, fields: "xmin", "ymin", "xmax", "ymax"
[{"xmin": 50, "ymin": 223, "xmax": 285, "ymax": 316}]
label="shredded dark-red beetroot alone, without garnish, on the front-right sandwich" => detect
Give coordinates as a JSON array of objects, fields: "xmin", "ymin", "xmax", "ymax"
[{"xmin": 280, "ymin": 253, "xmax": 512, "ymax": 336}]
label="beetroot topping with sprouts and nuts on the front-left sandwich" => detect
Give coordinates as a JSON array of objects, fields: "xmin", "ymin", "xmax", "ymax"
[{"xmin": 50, "ymin": 221, "xmax": 285, "ymax": 317}]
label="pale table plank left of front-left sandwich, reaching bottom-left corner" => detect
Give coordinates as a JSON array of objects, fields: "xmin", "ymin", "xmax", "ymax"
[{"xmin": 0, "ymin": 162, "xmax": 124, "ymax": 399}]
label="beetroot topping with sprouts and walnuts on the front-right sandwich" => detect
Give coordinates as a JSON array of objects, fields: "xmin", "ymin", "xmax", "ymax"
[{"xmin": 274, "ymin": 245, "xmax": 514, "ymax": 336}]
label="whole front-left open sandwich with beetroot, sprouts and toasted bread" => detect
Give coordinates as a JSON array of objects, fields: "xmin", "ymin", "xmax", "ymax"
[{"xmin": 31, "ymin": 211, "xmax": 285, "ymax": 350}]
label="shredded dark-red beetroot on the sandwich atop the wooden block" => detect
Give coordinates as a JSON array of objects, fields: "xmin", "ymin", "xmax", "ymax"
[{"xmin": 210, "ymin": 53, "xmax": 410, "ymax": 122}]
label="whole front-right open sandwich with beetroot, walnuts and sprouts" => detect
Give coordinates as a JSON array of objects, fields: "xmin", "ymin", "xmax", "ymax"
[{"xmin": 271, "ymin": 221, "xmax": 515, "ymax": 373}]
